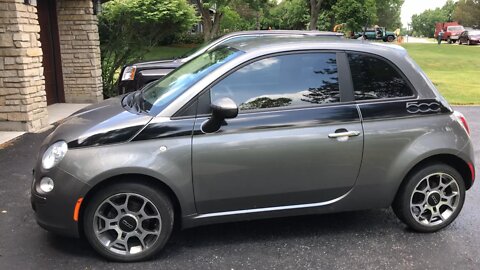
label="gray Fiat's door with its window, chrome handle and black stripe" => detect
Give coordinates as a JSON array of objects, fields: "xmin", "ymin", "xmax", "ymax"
[{"xmin": 192, "ymin": 52, "xmax": 363, "ymax": 214}]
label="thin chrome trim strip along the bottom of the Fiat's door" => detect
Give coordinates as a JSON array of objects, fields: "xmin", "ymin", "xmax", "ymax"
[{"xmin": 194, "ymin": 189, "xmax": 352, "ymax": 219}]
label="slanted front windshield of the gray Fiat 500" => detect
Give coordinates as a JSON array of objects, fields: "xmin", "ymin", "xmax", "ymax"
[{"xmin": 142, "ymin": 46, "xmax": 243, "ymax": 115}]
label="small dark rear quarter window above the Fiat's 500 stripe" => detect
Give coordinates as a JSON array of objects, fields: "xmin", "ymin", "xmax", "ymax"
[{"xmin": 348, "ymin": 53, "xmax": 413, "ymax": 100}]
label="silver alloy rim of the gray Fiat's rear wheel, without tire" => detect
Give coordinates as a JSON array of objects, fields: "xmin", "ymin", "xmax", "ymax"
[{"xmin": 410, "ymin": 173, "xmax": 461, "ymax": 226}]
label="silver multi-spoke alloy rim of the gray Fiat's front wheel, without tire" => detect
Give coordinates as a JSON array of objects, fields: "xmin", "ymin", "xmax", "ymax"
[{"xmin": 93, "ymin": 193, "xmax": 162, "ymax": 256}]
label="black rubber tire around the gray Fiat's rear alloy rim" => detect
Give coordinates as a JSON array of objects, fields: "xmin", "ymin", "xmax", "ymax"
[{"xmin": 392, "ymin": 163, "xmax": 465, "ymax": 232}]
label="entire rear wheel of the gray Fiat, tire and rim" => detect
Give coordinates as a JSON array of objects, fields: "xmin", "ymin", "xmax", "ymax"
[{"xmin": 392, "ymin": 163, "xmax": 465, "ymax": 232}]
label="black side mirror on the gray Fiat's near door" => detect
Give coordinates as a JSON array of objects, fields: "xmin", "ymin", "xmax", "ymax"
[{"xmin": 202, "ymin": 98, "xmax": 238, "ymax": 133}]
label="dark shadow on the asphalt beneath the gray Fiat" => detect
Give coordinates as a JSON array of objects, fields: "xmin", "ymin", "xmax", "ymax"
[{"xmin": 47, "ymin": 209, "xmax": 404, "ymax": 260}]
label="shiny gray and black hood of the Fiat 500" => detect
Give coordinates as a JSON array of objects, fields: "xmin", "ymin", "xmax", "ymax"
[{"xmin": 45, "ymin": 96, "xmax": 152, "ymax": 148}]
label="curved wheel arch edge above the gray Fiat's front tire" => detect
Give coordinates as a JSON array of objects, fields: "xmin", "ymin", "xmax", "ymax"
[{"xmin": 77, "ymin": 173, "xmax": 183, "ymax": 237}]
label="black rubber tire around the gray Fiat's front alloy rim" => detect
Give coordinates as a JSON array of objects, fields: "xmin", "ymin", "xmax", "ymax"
[{"xmin": 83, "ymin": 182, "xmax": 174, "ymax": 262}]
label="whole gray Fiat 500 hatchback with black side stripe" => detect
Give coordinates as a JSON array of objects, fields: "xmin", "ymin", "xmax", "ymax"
[{"xmin": 32, "ymin": 38, "xmax": 475, "ymax": 261}]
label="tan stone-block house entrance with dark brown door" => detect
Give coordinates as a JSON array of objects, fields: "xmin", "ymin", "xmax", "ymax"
[{"xmin": 0, "ymin": 0, "xmax": 103, "ymax": 132}]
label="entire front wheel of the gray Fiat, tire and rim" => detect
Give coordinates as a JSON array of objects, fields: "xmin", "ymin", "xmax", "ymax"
[{"xmin": 83, "ymin": 182, "xmax": 174, "ymax": 262}]
